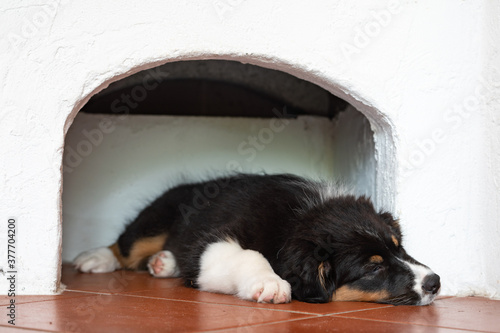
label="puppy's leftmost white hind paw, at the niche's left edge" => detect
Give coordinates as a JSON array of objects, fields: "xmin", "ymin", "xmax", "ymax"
[{"xmin": 73, "ymin": 247, "xmax": 121, "ymax": 273}]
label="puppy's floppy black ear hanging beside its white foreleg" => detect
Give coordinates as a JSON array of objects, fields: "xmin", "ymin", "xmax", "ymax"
[{"xmin": 283, "ymin": 241, "xmax": 335, "ymax": 303}]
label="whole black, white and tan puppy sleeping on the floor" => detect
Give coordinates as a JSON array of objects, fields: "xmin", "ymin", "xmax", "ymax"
[{"xmin": 75, "ymin": 175, "xmax": 440, "ymax": 305}]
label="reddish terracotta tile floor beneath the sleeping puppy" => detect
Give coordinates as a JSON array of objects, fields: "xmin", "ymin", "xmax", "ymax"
[{"xmin": 0, "ymin": 265, "xmax": 500, "ymax": 333}]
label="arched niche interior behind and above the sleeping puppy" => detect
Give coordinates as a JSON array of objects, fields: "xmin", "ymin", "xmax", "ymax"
[{"xmin": 62, "ymin": 60, "xmax": 393, "ymax": 261}]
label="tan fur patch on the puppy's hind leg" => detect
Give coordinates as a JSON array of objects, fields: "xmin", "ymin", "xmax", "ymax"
[{"xmin": 109, "ymin": 234, "xmax": 167, "ymax": 269}]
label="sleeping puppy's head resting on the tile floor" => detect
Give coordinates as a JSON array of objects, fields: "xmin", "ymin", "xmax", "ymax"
[{"xmin": 284, "ymin": 196, "xmax": 441, "ymax": 305}]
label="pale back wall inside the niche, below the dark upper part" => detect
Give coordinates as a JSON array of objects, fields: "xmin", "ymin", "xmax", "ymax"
[{"xmin": 63, "ymin": 110, "xmax": 375, "ymax": 261}]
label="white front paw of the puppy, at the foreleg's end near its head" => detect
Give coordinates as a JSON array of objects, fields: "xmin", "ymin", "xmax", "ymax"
[{"xmin": 238, "ymin": 274, "xmax": 292, "ymax": 304}]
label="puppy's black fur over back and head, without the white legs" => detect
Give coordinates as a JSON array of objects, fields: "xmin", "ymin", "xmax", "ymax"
[{"xmin": 76, "ymin": 174, "xmax": 440, "ymax": 304}]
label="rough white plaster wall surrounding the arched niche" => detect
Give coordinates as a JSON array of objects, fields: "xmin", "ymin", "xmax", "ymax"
[{"xmin": 0, "ymin": 0, "xmax": 500, "ymax": 297}]
